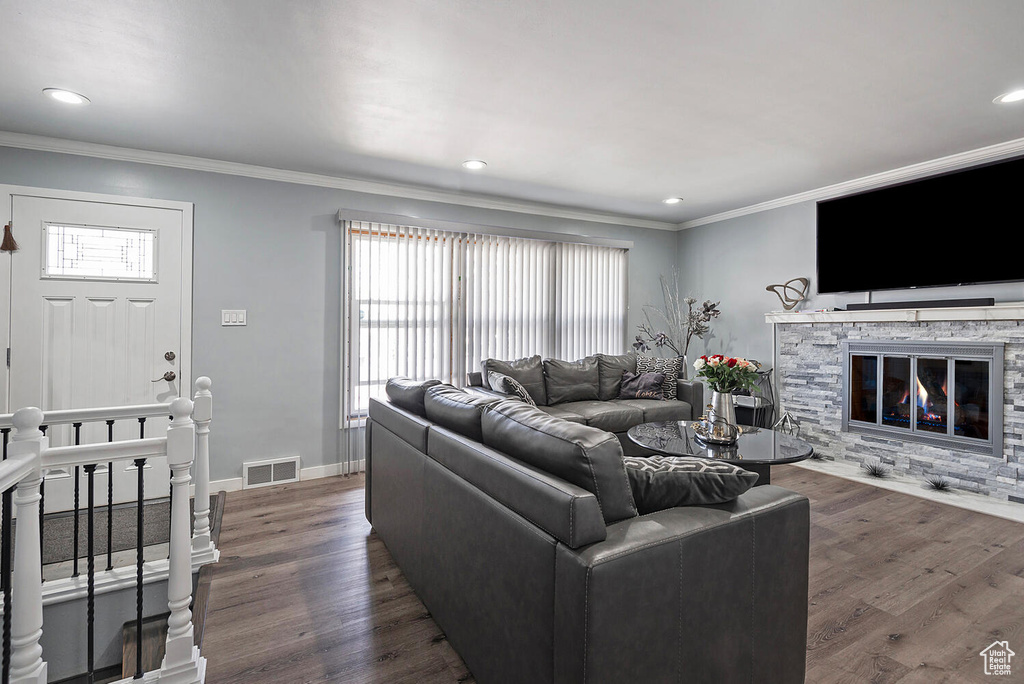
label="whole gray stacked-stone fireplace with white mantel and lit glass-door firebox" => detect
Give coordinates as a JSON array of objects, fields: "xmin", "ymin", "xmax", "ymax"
[{"xmin": 766, "ymin": 305, "xmax": 1024, "ymax": 503}]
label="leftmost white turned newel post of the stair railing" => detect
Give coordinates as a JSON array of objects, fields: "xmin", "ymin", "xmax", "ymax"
[{"xmin": 8, "ymin": 408, "xmax": 47, "ymax": 684}]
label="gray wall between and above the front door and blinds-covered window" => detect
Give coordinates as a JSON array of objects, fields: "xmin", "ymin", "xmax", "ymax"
[{"xmin": 0, "ymin": 147, "xmax": 677, "ymax": 479}]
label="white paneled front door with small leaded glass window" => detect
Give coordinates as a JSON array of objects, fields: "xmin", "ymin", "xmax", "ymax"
[{"xmin": 8, "ymin": 189, "xmax": 191, "ymax": 511}]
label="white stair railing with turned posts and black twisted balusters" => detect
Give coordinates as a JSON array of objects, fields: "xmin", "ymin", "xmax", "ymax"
[{"xmin": 0, "ymin": 377, "xmax": 219, "ymax": 684}]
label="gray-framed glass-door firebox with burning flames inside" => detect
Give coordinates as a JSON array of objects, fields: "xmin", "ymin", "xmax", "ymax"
[{"xmin": 843, "ymin": 341, "xmax": 1002, "ymax": 456}]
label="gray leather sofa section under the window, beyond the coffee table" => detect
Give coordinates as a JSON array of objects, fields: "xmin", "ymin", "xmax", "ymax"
[{"xmin": 469, "ymin": 353, "xmax": 703, "ymax": 455}]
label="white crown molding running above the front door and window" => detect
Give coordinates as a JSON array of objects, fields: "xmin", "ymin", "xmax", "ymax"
[{"xmin": 0, "ymin": 131, "xmax": 679, "ymax": 230}]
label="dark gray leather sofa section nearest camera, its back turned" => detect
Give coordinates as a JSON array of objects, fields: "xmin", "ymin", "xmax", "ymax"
[{"xmin": 366, "ymin": 382, "xmax": 809, "ymax": 684}]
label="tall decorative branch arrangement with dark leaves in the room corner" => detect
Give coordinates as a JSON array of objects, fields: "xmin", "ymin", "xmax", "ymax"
[{"xmin": 633, "ymin": 271, "xmax": 722, "ymax": 356}]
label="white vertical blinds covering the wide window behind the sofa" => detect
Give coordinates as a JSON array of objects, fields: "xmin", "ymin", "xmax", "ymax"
[{"xmin": 342, "ymin": 221, "xmax": 628, "ymax": 428}]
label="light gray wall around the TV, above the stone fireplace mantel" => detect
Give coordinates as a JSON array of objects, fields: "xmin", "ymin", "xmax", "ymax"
[{"xmin": 679, "ymin": 202, "xmax": 1024, "ymax": 365}]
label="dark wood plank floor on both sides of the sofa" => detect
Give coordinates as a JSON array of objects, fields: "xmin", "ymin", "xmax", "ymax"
[{"xmin": 203, "ymin": 466, "xmax": 1024, "ymax": 684}]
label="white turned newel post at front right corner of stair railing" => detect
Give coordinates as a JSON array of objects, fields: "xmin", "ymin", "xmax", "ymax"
[{"xmin": 160, "ymin": 397, "xmax": 206, "ymax": 684}]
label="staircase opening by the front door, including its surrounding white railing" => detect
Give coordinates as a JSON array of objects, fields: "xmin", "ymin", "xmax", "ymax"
[{"xmin": 0, "ymin": 378, "xmax": 219, "ymax": 684}]
